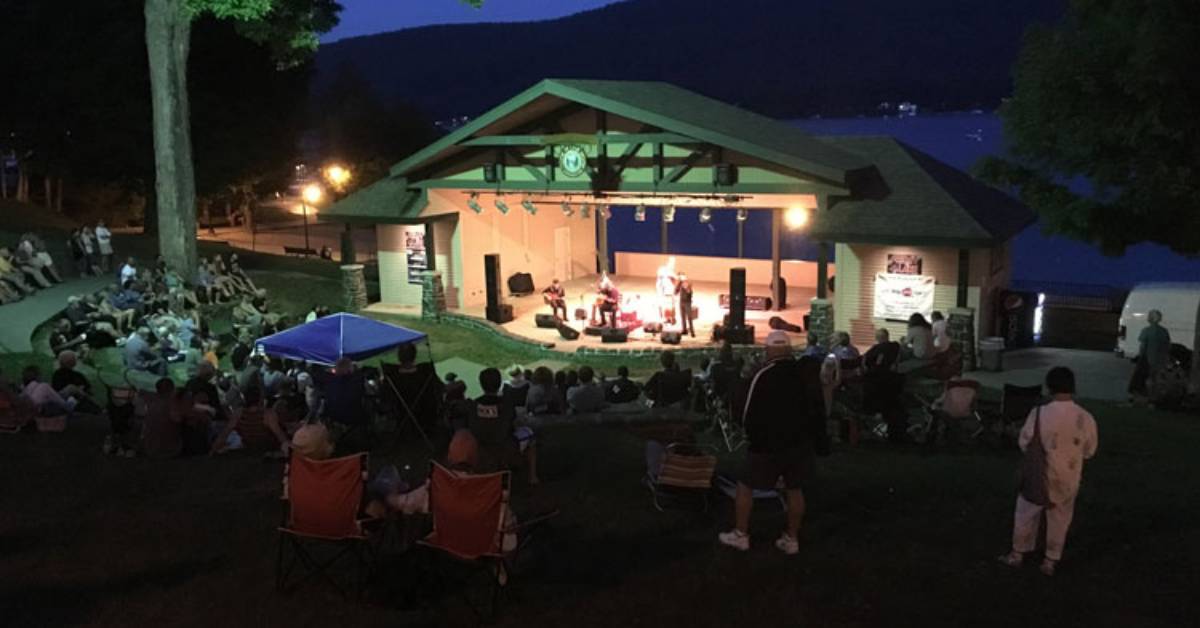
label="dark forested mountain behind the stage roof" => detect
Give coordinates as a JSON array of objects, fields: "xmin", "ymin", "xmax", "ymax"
[{"xmin": 316, "ymin": 0, "xmax": 1062, "ymax": 118}]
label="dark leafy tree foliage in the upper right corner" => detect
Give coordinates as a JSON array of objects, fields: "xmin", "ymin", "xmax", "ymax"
[{"xmin": 979, "ymin": 0, "xmax": 1200, "ymax": 255}]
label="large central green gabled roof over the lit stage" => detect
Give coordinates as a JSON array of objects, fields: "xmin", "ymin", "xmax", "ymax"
[{"xmin": 391, "ymin": 79, "xmax": 870, "ymax": 185}]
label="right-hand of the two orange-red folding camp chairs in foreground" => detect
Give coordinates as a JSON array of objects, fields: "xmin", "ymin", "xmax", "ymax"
[{"xmin": 418, "ymin": 462, "xmax": 558, "ymax": 620}]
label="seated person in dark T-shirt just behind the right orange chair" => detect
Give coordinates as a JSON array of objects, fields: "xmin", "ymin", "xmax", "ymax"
[{"xmin": 469, "ymin": 369, "xmax": 539, "ymax": 484}]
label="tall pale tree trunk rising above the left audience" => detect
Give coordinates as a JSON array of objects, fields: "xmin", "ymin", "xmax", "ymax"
[{"xmin": 145, "ymin": 0, "xmax": 196, "ymax": 277}]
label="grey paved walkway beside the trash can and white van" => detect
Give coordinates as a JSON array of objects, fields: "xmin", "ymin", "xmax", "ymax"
[{"xmin": 967, "ymin": 347, "xmax": 1133, "ymax": 401}]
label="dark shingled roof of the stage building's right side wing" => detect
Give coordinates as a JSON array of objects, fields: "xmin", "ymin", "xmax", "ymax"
[{"xmin": 811, "ymin": 136, "xmax": 1036, "ymax": 247}]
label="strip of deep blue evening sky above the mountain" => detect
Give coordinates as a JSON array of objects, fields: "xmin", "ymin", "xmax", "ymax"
[{"xmin": 322, "ymin": 0, "xmax": 620, "ymax": 42}]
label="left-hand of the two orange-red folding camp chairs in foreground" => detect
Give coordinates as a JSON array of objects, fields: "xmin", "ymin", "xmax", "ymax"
[{"xmin": 275, "ymin": 453, "xmax": 379, "ymax": 596}]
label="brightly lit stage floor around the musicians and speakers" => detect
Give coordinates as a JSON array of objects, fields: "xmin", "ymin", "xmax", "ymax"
[{"xmin": 492, "ymin": 276, "xmax": 816, "ymax": 352}]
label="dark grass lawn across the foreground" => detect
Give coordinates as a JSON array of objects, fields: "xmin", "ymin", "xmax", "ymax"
[{"xmin": 0, "ymin": 405, "xmax": 1200, "ymax": 628}]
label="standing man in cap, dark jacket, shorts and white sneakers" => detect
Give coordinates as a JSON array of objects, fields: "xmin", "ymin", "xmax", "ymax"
[{"xmin": 718, "ymin": 330, "xmax": 824, "ymax": 555}]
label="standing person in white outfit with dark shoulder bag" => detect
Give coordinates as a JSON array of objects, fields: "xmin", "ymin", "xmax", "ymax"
[{"xmin": 1000, "ymin": 366, "xmax": 1098, "ymax": 575}]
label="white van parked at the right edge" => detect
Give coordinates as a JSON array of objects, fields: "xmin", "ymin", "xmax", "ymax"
[{"xmin": 1116, "ymin": 283, "xmax": 1200, "ymax": 359}]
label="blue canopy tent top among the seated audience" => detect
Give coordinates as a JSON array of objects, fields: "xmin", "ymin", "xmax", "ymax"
[{"xmin": 254, "ymin": 312, "xmax": 428, "ymax": 366}]
